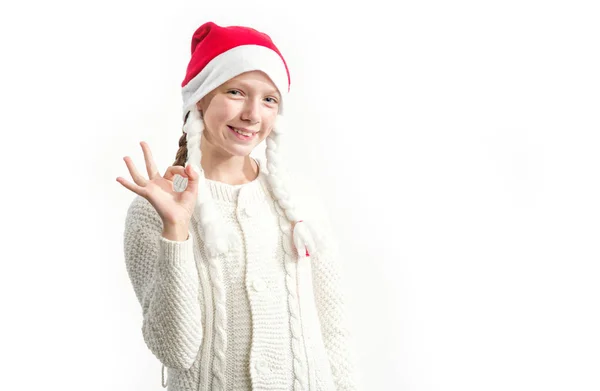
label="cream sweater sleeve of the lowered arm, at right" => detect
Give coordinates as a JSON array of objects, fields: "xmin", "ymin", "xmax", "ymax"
[{"xmin": 311, "ymin": 195, "xmax": 358, "ymax": 391}]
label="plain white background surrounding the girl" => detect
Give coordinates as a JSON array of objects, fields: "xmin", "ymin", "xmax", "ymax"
[{"xmin": 0, "ymin": 0, "xmax": 600, "ymax": 391}]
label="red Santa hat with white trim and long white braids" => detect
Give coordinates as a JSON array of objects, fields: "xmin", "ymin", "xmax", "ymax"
[{"xmin": 181, "ymin": 22, "xmax": 317, "ymax": 257}]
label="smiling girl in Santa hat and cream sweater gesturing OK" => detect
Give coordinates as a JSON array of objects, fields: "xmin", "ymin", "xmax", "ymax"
[{"xmin": 117, "ymin": 22, "xmax": 356, "ymax": 391}]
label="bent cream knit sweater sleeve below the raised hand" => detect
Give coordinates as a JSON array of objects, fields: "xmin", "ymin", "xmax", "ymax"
[{"xmin": 124, "ymin": 196, "xmax": 203, "ymax": 369}]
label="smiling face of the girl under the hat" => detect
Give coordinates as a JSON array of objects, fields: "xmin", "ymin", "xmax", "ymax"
[{"xmin": 196, "ymin": 71, "xmax": 281, "ymax": 156}]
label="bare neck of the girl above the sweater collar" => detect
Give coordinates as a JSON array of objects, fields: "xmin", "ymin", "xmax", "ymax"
[{"xmin": 200, "ymin": 133, "xmax": 258, "ymax": 185}]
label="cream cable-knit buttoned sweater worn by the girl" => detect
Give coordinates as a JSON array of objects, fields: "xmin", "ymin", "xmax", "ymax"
[{"xmin": 124, "ymin": 161, "xmax": 356, "ymax": 391}]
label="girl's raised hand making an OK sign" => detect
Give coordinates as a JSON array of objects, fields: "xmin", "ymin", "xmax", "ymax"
[{"xmin": 117, "ymin": 141, "xmax": 198, "ymax": 227}]
